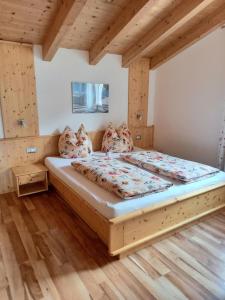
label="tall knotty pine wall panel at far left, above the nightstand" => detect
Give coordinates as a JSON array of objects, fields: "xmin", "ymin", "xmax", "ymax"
[{"xmin": 0, "ymin": 42, "xmax": 39, "ymax": 138}]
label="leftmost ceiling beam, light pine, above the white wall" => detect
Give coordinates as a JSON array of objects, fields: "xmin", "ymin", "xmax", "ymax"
[{"xmin": 43, "ymin": 0, "xmax": 87, "ymax": 61}]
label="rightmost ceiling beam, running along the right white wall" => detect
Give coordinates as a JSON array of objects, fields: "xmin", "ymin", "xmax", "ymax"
[{"xmin": 150, "ymin": 5, "xmax": 225, "ymax": 69}]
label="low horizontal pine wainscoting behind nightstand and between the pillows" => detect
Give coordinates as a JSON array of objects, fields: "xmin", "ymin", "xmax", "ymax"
[{"xmin": 0, "ymin": 131, "xmax": 104, "ymax": 194}]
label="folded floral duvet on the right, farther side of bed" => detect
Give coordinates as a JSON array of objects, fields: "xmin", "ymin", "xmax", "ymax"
[{"xmin": 121, "ymin": 151, "xmax": 219, "ymax": 182}]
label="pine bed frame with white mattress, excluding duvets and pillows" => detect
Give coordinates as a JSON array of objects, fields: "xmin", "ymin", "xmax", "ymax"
[{"xmin": 45, "ymin": 152, "xmax": 225, "ymax": 256}]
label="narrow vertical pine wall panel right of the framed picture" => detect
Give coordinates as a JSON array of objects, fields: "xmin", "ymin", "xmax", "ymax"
[{"xmin": 128, "ymin": 58, "xmax": 153, "ymax": 148}]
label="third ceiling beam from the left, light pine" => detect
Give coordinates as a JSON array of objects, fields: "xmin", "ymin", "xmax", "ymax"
[{"xmin": 122, "ymin": 0, "xmax": 215, "ymax": 67}]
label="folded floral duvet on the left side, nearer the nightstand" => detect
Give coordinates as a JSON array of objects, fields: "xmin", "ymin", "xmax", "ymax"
[{"xmin": 72, "ymin": 157, "xmax": 172, "ymax": 199}]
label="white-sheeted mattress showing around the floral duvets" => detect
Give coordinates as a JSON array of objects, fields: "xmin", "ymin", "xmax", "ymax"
[{"xmin": 45, "ymin": 152, "xmax": 225, "ymax": 219}]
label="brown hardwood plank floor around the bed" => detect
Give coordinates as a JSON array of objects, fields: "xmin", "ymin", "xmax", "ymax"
[{"xmin": 0, "ymin": 192, "xmax": 225, "ymax": 300}]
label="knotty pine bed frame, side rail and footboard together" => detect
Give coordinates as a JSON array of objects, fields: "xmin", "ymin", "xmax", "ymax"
[{"xmin": 49, "ymin": 172, "xmax": 225, "ymax": 256}]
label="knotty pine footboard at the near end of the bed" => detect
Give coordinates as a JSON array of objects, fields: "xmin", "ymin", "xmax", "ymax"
[{"xmin": 109, "ymin": 186, "xmax": 225, "ymax": 256}]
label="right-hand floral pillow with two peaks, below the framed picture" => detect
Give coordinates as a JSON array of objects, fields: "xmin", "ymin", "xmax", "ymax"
[{"xmin": 102, "ymin": 123, "xmax": 133, "ymax": 152}]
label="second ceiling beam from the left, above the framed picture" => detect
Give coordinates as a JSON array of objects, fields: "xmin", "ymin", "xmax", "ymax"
[{"xmin": 89, "ymin": 0, "xmax": 158, "ymax": 65}]
